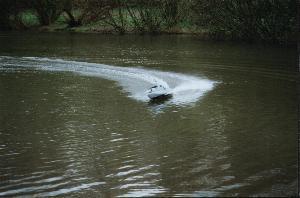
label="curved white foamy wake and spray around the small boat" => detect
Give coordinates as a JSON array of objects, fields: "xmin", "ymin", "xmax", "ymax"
[{"xmin": 0, "ymin": 56, "xmax": 215, "ymax": 105}]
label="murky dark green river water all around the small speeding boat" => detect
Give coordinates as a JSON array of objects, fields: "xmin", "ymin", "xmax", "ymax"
[{"xmin": 0, "ymin": 33, "xmax": 298, "ymax": 197}]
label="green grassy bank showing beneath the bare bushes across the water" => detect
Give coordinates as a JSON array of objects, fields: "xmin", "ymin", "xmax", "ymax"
[{"xmin": 17, "ymin": 10, "xmax": 197, "ymax": 34}]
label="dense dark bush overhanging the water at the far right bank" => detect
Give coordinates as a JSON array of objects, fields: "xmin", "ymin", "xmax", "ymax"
[{"xmin": 193, "ymin": 0, "xmax": 297, "ymax": 41}]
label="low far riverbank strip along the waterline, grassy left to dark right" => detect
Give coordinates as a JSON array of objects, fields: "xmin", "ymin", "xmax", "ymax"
[{"xmin": 2, "ymin": 11, "xmax": 298, "ymax": 45}]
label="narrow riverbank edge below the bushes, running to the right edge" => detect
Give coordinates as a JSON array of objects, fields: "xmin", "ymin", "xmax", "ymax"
[{"xmin": 8, "ymin": 17, "xmax": 297, "ymax": 45}]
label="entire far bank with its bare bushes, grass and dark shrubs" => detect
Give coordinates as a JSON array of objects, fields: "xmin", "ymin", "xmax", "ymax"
[{"xmin": 0, "ymin": 0, "xmax": 297, "ymax": 42}]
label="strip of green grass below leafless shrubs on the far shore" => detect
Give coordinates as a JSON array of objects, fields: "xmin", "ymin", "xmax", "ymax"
[{"xmin": 16, "ymin": 11, "xmax": 213, "ymax": 39}]
